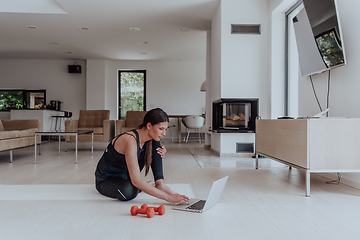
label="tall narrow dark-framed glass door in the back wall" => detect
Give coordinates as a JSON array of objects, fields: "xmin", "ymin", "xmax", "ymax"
[{"xmin": 118, "ymin": 70, "xmax": 146, "ymax": 119}]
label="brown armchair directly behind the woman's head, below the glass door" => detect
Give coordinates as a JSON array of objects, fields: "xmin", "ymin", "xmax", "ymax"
[{"xmin": 115, "ymin": 111, "xmax": 147, "ymax": 136}]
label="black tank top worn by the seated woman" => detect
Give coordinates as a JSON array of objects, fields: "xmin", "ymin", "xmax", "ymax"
[{"xmin": 95, "ymin": 129, "xmax": 145, "ymax": 183}]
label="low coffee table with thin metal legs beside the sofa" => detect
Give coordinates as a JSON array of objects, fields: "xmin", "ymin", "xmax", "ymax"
[{"xmin": 35, "ymin": 130, "xmax": 94, "ymax": 164}]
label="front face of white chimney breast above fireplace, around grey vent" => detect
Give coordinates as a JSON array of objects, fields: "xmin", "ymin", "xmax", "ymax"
[{"xmin": 221, "ymin": 0, "xmax": 269, "ymax": 118}]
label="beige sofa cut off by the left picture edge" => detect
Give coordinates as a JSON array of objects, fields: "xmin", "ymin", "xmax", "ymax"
[{"xmin": 0, "ymin": 119, "xmax": 41, "ymax": 163}]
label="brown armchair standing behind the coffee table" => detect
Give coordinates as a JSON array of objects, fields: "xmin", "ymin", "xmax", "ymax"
[{"xmin": 65, "ymin": 110, "xmax": 115, "ymax": 142}]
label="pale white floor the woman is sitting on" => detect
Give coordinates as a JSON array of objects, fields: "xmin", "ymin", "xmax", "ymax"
[{"xmin": 0, "ymin": 142, "xmax": 360, "ymax": 240}]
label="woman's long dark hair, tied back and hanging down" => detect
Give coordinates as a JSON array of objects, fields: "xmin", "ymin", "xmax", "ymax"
[{"xmin": 139, "ymin": 108, "xmax": 169, "ymax": 176}]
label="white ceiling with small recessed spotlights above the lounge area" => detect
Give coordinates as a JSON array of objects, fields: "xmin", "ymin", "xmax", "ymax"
[{"xmin": 0, "ymin": 0, "xmax": 219, "ymax": 60}]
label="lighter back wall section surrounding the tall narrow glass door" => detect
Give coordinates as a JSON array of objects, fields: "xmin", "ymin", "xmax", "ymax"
[{"xmin": 86, "ymin": 59, "xmax": 206, "ymax": 119}]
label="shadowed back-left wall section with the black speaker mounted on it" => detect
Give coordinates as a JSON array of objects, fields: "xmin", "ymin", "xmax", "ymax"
[{"xmin": 0, "ymin": 59, "xmax": 86, "ymax": 119}]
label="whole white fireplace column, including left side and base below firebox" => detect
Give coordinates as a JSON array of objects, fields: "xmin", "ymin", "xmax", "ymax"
[{"xmin": 211, "ymin": 0, "xmax": 270, "ymax": 155}]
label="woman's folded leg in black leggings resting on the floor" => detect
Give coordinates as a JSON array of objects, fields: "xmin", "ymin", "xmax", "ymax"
[{"xmin": 96, "ymin": 177, "xmax": 140, "ymax": 201}]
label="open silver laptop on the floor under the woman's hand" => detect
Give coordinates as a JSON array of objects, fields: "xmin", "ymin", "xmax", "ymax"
[{"xmin": 173, "ymin": 176, "xmax": 229, "ymax": 213}]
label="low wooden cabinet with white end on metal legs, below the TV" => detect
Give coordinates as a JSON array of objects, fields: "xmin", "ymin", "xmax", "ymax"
[{"xmin": 256, "ymin": 118, "xmax": 360, "ymax": 196}]
